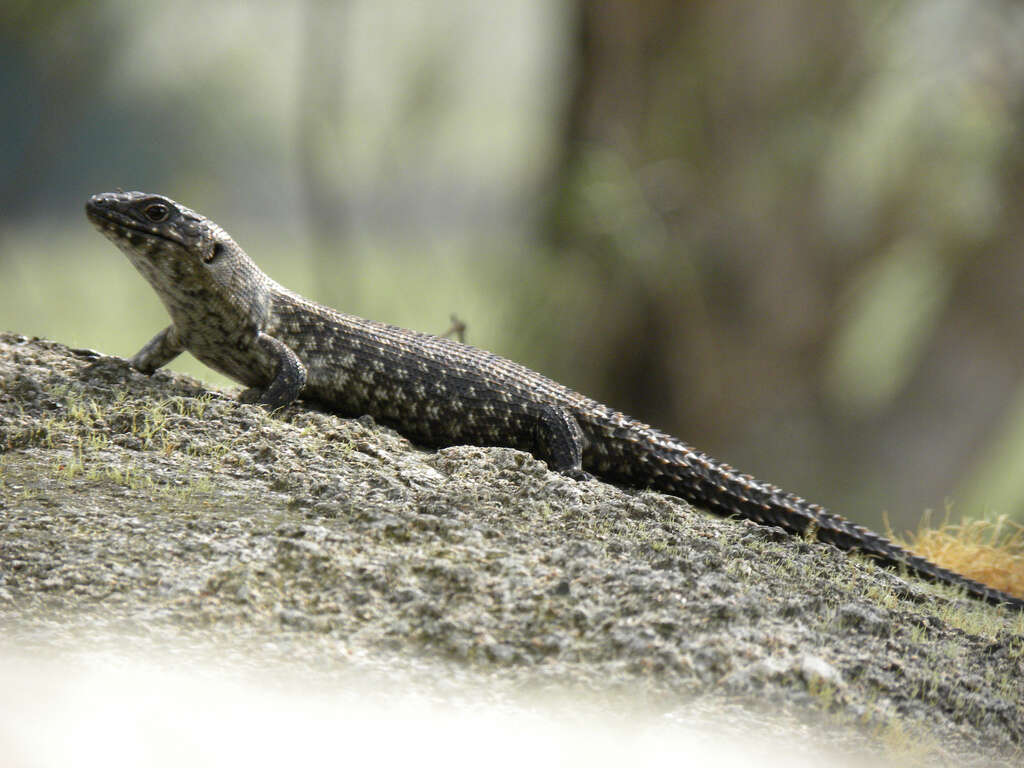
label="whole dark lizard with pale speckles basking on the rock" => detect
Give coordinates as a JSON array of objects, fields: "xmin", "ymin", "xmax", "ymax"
[{"xmin": 85, "ymin": 190, "xmax": 1024, "ymax": 610}]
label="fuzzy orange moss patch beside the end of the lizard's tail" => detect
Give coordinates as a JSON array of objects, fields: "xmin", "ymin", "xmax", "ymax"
[{"xmin": 905, "ymin": 514, "xmax": 1024, "ymax": 597}]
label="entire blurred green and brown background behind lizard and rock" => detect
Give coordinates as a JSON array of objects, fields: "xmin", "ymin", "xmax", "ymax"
[{"xmin": 6, "ymin": 0, "xmax": 1024, "ymax": 530}]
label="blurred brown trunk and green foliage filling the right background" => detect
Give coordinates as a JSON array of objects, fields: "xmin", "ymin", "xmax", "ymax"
[{"xmin": 538, "ymin": 0, "xmax": 1024, "ymax": 518}]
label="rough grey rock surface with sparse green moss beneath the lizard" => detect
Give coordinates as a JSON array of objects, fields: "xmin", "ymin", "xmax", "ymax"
[{"xmin": 0, "ymin": 334, "xmax": 1024, "ymax": 765}]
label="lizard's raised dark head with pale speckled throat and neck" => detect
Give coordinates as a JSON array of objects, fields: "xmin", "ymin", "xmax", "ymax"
[{"xmin": 85, "ymin": 191, "xmax": 267, "ymax": 331}]
